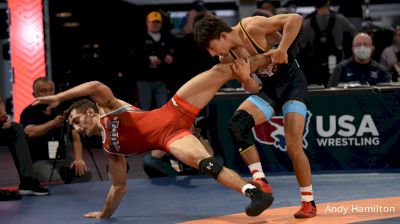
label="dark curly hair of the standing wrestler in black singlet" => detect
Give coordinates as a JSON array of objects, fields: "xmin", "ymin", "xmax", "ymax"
[{"xmin": 193, "ymin": 15, "xmax": 232, "ymax": 50}]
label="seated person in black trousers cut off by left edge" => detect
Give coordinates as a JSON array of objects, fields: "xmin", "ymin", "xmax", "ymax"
[{"xmin": 0, "ymin": 96, "xmax": 49, "ymax": 201}]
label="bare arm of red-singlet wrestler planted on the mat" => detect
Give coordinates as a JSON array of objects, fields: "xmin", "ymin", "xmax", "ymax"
[{"xmin": 85, "ymin": 154, "xmax": 127, "ymax": 218}]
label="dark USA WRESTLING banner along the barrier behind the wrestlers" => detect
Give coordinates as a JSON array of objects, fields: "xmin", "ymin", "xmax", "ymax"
[{"xmin": 209, "ymin": 90, "xmax": 400, "ymax": 172}]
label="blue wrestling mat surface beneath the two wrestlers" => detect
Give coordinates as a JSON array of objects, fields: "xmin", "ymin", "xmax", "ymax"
[{"xmin": 0, "ymin": 173, "xmax": 400, "ymax": 224}]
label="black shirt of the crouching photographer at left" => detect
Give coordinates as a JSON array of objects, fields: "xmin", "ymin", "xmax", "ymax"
[{"xmin": 20, "ymin": 105, "xmax": 65, "ymax": 162}]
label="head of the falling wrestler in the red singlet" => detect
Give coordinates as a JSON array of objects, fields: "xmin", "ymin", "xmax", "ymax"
[{"xmin": 67, "ymin": 99, "xmax": 102, "ymax": 136}]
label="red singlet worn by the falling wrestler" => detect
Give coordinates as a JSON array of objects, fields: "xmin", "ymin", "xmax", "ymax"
[{"xmin": 100, "ymin": 95, "xmax": 200, "ymax": 155}]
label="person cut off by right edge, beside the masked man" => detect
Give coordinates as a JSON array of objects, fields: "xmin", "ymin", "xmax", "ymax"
[{"xmin": 380, "ymin": 26, "xmax": 400, "ymax": 82}]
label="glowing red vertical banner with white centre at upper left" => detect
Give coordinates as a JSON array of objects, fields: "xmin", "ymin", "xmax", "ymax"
[{"xmin": 8, "ymin": 0, "xmax": 46, "ymax": 121}]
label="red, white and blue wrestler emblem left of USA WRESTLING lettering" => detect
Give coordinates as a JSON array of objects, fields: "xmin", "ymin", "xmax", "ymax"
[{"xmin": 253, "ymin": 111, "xmax": 312, "ymax": 151}]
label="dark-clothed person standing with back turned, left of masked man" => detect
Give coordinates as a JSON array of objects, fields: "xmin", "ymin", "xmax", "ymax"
[{"xmin": 297, "ymin": 0, "xmax": 356, "ymax": 85}]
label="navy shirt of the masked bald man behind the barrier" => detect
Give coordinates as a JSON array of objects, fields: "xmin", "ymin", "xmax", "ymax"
[{"xmin": 328, "ymin": 58, "xmax": 390, "ymax": 87}]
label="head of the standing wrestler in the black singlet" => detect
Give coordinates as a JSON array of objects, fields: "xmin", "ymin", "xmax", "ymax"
[{"xmin": 193, "ymin": 15, "xmax": 233, "ymax": 57}]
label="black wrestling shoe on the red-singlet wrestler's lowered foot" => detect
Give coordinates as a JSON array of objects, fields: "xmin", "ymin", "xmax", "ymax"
[{"xmin": 245, "ymin": 188, "xmax": 274, "ymax": 216}]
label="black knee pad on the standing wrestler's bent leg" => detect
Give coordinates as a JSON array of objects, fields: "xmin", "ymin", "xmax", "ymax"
[{"xmin": 228, "ymin": 110, "xmax": 255, "ymax": 153}]
